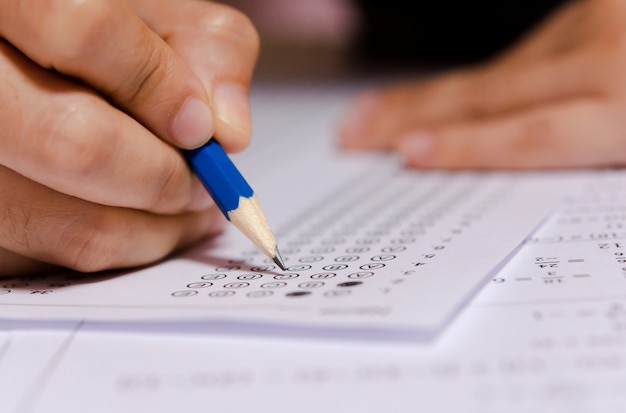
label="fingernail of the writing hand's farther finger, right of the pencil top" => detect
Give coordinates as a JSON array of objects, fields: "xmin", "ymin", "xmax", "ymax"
[{"xmin": 213, "ymin": 83, "xmax": 251, "ymax": 138}]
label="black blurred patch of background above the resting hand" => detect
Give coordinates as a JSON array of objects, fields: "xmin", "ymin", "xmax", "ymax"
[{"xmin": 352, "ymin": 0, "xmax": 565, "ymax": 63}]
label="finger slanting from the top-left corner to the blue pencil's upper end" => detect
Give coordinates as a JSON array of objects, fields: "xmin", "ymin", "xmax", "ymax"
[{"xmin": 0, "ymin": 0, "xmax": 214, "ymax": 148}]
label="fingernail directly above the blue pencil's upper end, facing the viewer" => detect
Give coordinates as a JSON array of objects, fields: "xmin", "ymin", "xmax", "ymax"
[{"xmin": 171, "ymin": 97, "xmax": 214, "ymax": 149}]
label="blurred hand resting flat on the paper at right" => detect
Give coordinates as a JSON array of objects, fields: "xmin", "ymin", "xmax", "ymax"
[{"xmin": 340, "ymin": 0, "xmax": 626, "ymax": 169}]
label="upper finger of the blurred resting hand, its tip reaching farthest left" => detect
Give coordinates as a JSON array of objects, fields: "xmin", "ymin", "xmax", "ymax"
[{"xmin": 340, "ymin": 49, "xmax": 597, "ymax": 149}]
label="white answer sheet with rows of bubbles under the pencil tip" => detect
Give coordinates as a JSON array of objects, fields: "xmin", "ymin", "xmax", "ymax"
[{"xmin": 0, "ymin": 85, "xmax": 572, "ymax": 339}]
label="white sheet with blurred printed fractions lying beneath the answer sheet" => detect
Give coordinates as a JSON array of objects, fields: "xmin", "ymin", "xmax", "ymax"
[{"xmin": 9, "ymin": 172, "xmax": 626, "ymax": 413}]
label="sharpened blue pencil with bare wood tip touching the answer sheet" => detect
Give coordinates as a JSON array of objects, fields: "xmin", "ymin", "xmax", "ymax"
[{"xmin": 183, "ymin": 139, "xmax": 287, "ymax": 271}]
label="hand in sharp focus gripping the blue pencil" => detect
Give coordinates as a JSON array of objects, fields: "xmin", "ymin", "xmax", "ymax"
[{"xmin": 0, "ymin": 0, "xmax": 258, "ymax": 275}]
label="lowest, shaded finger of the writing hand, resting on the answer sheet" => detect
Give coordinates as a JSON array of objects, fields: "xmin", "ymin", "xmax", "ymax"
[{"xmin": 0, "ymin": 167, "xmax": 223, "ymax": 274}]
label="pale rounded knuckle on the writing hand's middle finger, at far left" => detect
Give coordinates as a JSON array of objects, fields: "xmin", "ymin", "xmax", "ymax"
[{"xmin": 23, "ymin": 99, "xmax": 118, "ymax": 178}]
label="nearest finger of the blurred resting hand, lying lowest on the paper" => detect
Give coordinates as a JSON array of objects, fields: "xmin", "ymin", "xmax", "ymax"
[{"xmin": 396, "ymin": 99, "xmax": 626, "ymax": 169}]
